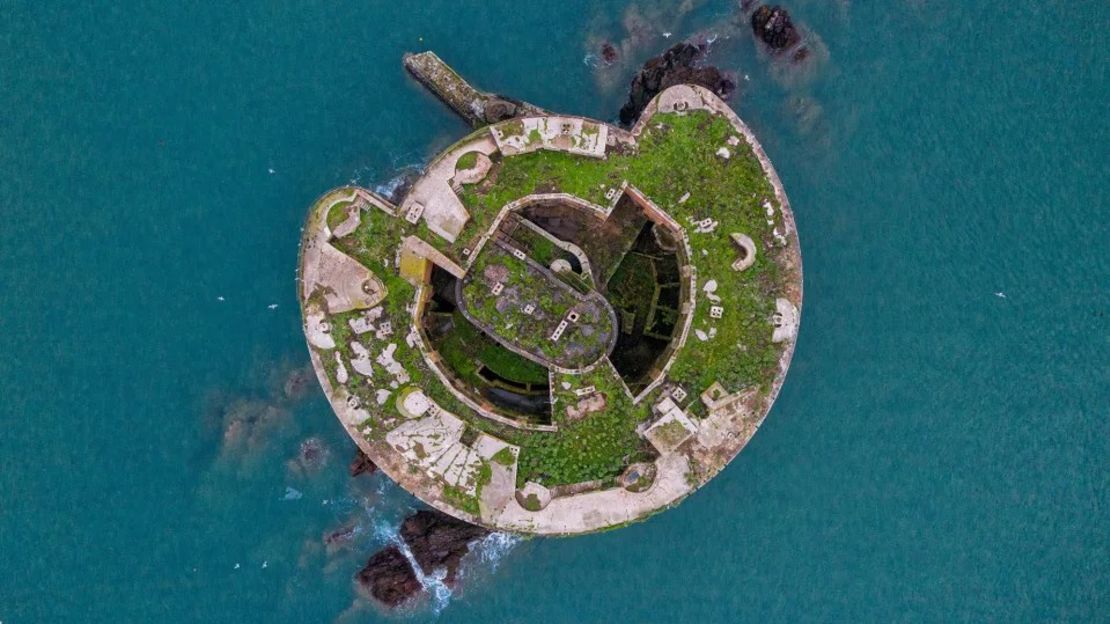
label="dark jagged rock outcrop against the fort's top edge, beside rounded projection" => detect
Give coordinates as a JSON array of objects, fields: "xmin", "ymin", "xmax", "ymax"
[{"xmin": 620, "ymin": 42, "xmax": 736, "ymax": 125}]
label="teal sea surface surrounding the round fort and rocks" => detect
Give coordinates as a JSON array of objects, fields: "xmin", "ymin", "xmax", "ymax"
[{"xmin": 0, "ymin": 0, "xmax": 1110, "ymax": 624}]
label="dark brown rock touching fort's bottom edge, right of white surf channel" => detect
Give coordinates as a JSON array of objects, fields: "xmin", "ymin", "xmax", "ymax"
[{"xmin": 401, "ymin": 511, "xmax": 490, "ymax": 585}]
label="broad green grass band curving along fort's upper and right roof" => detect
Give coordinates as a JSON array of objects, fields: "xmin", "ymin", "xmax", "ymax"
[{"xmin": 461, "ymin": 111, "xmax": 781, "ymax": 390}]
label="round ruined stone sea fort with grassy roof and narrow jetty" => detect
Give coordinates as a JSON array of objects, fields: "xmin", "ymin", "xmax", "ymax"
[{"xmin": 297, "ymin": 53, "xmax": 801, "ymax": 535}]
